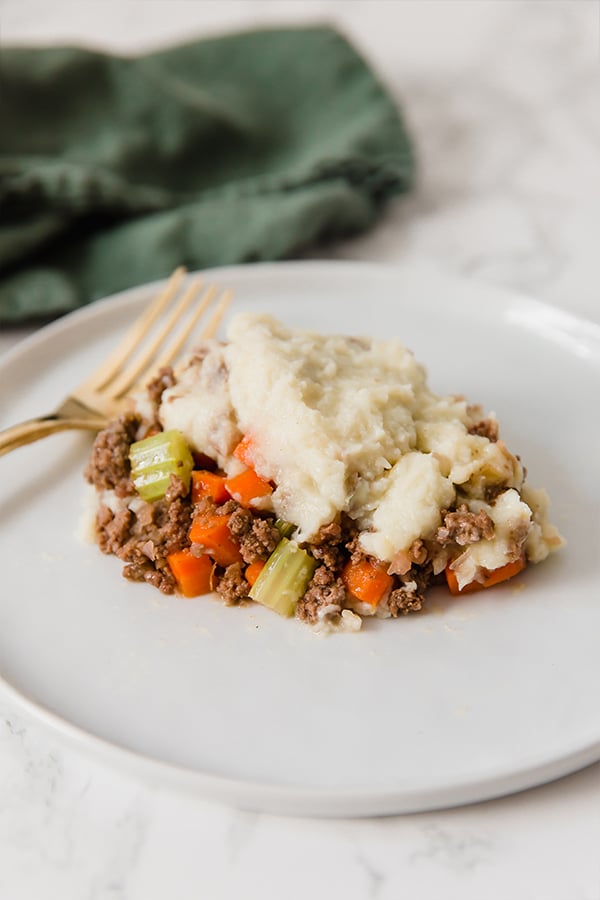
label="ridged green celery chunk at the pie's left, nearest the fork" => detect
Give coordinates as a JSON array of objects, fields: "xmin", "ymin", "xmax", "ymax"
[{"xmin": 129, "ymin": 430, "xmax": 194, "ymax": 502}]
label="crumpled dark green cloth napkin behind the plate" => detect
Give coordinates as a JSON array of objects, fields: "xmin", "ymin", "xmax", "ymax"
[{"xmin": 0, "ymin": 27, "xmax": 414, "ymax": 322}]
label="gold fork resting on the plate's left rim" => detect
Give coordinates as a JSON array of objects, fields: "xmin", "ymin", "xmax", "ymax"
[{"xmin": 0, "ymin": 268, "xmax": 232, "ymax": 456}]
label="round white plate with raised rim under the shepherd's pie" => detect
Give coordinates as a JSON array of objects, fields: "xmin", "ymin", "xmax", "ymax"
[{"xmin": 0, "ymin": 263, "xmax": 600, "ymax": 815}]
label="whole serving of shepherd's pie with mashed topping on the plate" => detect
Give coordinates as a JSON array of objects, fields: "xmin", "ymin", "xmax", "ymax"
[{"xmin": 86, "ymin": 315, "xmax": 562, "ymax": 630}]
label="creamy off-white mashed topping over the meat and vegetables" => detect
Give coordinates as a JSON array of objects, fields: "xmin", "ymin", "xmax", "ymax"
[{"xmin": 159, "ymin": 314, "xmax": 560, "ymax": 584}]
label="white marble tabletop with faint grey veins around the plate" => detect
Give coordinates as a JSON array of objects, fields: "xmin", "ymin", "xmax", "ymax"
[{"xmin": 0, "ymin": 0, "xmax": 600, "ymax": 900}]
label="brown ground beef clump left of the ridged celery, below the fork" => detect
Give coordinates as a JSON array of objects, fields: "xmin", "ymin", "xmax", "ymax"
[{"xmin": 84, "ymin": 413, "xmax": 141, "ymax": 497}]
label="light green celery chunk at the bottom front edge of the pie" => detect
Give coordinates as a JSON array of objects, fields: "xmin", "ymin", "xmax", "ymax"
[{"xmin": 250, "ymin": 538, "xmax": 317, "ymax": 616}]
